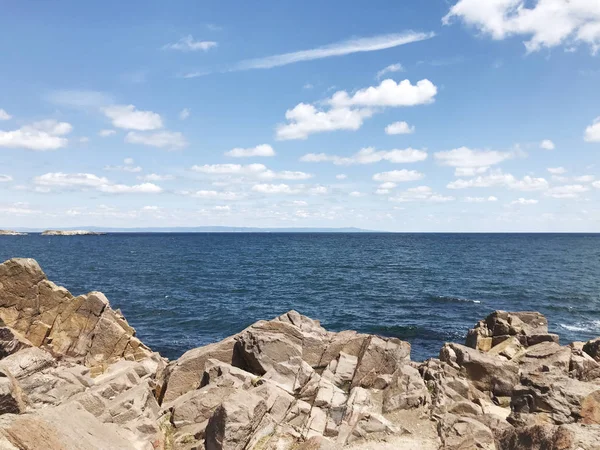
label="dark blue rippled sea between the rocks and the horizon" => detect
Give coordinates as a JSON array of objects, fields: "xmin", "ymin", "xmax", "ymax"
[{"xmin": 0, "ymin": 233, "xmax": 600, "ymax": 360}]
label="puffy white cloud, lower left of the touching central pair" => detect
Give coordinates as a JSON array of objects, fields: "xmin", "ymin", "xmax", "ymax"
[{"xmin": 276, "ymin": 103, "xmax": 373, "ymax": 141}]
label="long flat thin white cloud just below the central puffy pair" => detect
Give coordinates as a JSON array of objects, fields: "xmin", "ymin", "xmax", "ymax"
[{"xmin": 300, "ymin": 147, "xmax": 427, "ymax": 166}]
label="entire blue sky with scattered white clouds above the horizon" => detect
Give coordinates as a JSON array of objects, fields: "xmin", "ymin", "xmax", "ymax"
[{"xmin": 0, "ymin": 0, "xmax": 600, "ymax": 232}]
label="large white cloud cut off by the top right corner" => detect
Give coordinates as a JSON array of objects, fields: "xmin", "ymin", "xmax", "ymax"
[{"xmin": 443, "ymin": 0, "xmax": 600, "ymax": 52}]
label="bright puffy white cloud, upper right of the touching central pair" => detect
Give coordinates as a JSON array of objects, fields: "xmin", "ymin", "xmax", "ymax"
[{"xmin": 329, "ymin": 79, "xmax": 437, "ymax": 108}]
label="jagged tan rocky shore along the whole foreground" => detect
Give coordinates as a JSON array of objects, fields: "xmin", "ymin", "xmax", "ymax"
[{"xmin": 0, "ymin": 259, "xmax": 600, "ymax": 450}]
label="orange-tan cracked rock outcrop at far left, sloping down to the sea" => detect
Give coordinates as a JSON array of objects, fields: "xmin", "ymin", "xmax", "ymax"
[{"xmin": 0, "ymin": 258, "xmax": 151, "ymax": 372}]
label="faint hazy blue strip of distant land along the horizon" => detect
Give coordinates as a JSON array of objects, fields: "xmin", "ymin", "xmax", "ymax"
[{"xmin": 9, "ymin": 226, "xmax": 380, "ymax": 233}]
